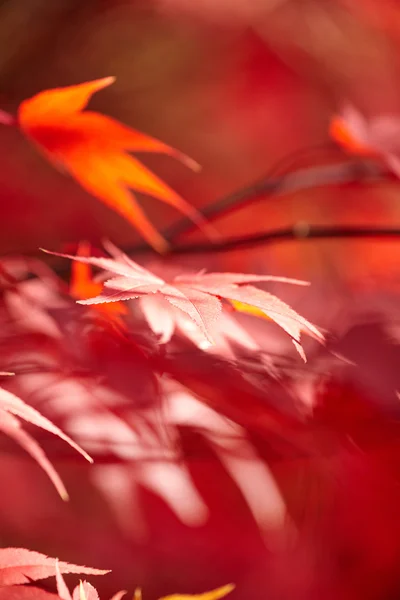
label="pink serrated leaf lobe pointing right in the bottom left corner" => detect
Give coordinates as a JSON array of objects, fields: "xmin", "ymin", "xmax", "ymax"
[{"xmin": 0, "ymin": 548, "xmax": 109, "ymax": 587}]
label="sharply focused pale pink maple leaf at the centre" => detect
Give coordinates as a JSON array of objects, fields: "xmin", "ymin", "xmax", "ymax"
[{"xmin": 43, "ymin": 244, "xmax": 324, "ymax": 358}]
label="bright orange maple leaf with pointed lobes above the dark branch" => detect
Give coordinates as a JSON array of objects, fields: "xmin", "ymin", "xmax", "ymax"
[{"xmin": 18, "ymin": 77, "xmax": 215, "ymax": 252}]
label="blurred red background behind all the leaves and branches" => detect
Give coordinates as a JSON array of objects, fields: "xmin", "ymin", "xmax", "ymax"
[{"xmin": 0, "ymin": 0, "xmax": 400, "ymax": 600}]
